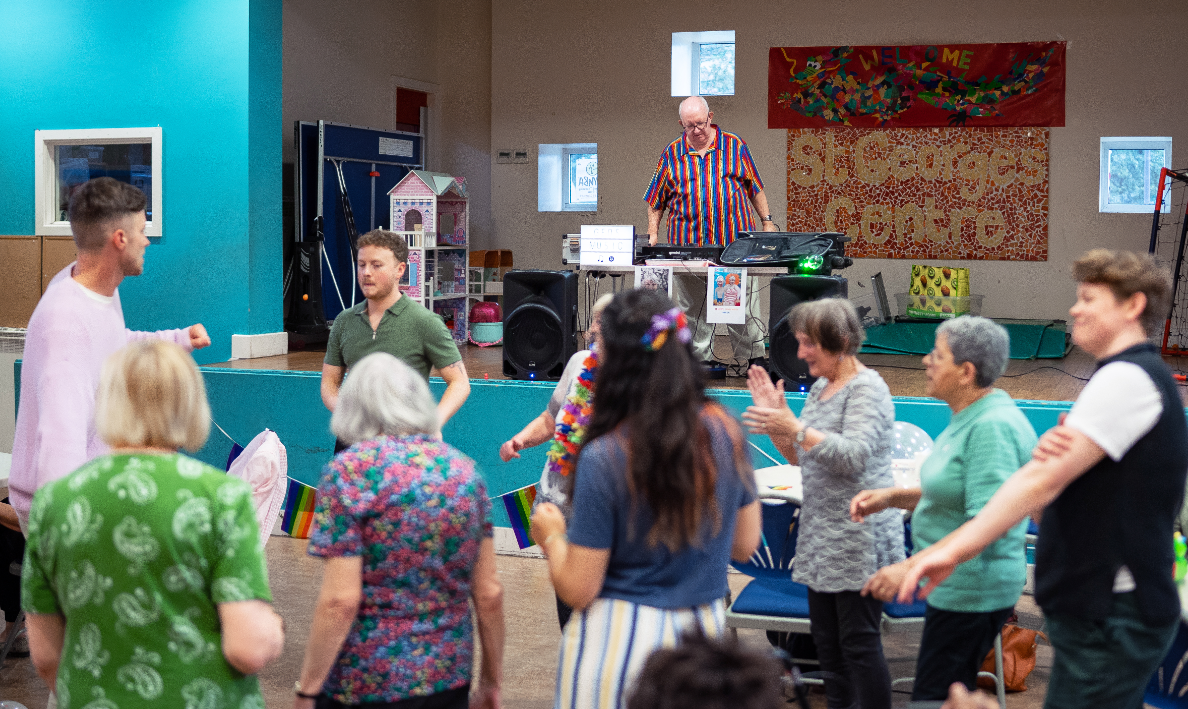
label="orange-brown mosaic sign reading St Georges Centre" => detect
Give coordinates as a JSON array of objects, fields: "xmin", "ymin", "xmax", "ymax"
[{"xmin": 788, "ymin": 128, "xmax": 1048, "ymax": 261}]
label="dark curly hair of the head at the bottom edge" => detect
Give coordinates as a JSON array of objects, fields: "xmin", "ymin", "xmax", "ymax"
[{"xmin": 627, "ymin": 635, "xmax": 786, "ymax": 709}]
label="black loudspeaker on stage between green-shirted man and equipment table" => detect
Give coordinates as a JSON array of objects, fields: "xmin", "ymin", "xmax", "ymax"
[{"xmin": 504, "ymin": 271, "xmax": 577, "ymax": 380}]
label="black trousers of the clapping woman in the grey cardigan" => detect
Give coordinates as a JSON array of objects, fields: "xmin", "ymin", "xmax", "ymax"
[{"xmin": 809, "ymin": 589, "xmax": 891, "ymax": 709}]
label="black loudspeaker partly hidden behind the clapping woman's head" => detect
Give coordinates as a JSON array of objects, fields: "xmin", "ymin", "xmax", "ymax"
[{"xmin": 767, "ymin": 276, "xmax": 849, "ymax": 392}]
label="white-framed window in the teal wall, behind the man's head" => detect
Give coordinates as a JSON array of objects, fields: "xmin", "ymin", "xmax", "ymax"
[{"xmin": 33, "ymin": 126, "xmax": 165, "ymax": 236}]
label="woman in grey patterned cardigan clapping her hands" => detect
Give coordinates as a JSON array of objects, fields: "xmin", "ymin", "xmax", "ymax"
[{"xmin": 743, "ymin": 298, "xmax": 904, "ymax": 709}]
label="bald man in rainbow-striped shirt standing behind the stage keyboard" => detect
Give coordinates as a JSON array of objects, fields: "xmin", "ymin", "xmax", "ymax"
[{"xmin": 644, "ymin": 96, "xmax": 777, "ymax": 363}]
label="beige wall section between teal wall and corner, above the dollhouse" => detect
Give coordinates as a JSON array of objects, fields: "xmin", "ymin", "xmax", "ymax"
[{"xmin": 280, "ymin": 0, "xmax": 491, "ymax": 243}]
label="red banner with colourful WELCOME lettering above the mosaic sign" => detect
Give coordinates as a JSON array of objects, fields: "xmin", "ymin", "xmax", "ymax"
[{"xmin": 767, "ymin": 42, "xmax": 1064, "ymax": 128}]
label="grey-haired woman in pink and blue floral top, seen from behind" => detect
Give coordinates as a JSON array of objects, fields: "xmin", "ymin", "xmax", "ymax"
[{"xmin": 293, "ymin": 353, "xmax": 504, "ymax": 709}]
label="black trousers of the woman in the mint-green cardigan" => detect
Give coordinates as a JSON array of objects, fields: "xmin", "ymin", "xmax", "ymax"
[{"xmin": 911, "ymin": 606, "xmax": 1015, "ymax": 701}]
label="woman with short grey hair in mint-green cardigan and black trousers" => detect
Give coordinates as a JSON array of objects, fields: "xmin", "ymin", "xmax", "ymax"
[{"xmin": 851, "ymin": 316, "xmax": 1036, "ymax": 701}]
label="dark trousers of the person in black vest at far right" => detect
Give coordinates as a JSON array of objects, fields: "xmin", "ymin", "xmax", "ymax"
[{"xmin": 1043, "ymin": 593, "xmax": 1180, "ymax": 709}]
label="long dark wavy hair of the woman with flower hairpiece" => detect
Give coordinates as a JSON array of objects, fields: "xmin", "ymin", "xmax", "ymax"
[{"xmin": 579, "ymin": 289, "xmax": 750, "ymax": 551}]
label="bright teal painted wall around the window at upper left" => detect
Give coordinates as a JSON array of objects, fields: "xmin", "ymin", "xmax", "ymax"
[{"xmin": 0, "ymin": 0, "xmax": 282, "ymax": 362}]
